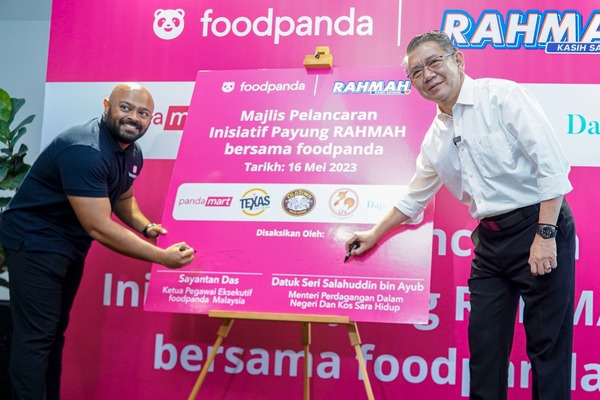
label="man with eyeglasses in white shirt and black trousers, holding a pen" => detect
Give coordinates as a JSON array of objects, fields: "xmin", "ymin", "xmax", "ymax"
[{"xmin": 346, "ymin": 31, "xmax": 575, "ymax": 400}]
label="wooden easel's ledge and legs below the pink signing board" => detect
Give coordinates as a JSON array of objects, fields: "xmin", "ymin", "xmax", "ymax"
[{"xmin": 188, "ymin": 311, "xmax": 375, "ymax": 400}]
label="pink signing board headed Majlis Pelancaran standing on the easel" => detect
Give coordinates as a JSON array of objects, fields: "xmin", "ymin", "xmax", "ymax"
[{"xmin": 146, "ymin": 67, "xmax": 434, "ymax": 323}]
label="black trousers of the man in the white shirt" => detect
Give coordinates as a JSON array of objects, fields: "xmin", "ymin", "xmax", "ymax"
[{"xmin": 469, "ymin": 202, "xmax": 575, "ymax": 400}]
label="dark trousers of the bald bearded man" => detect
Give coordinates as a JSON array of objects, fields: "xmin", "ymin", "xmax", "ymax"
[{"xmin": 5, "ymin": 246, "xmax": 83, "ymax": 400}]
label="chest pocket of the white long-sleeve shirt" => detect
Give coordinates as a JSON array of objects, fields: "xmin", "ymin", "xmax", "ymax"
[{"xmin": 471, "ymin": 131, "xmax": 517, "ymax": 178}]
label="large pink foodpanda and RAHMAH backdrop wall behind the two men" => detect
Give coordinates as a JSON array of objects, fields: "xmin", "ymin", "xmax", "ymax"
[{"xmin": 43, "ymin": 0, "xmax": 600, "ymax": 400}]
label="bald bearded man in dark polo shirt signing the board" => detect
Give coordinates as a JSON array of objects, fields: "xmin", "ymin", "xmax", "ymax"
[{"xmin": 0, "ymin": 83, "xmax": 194, "ymax": 400}]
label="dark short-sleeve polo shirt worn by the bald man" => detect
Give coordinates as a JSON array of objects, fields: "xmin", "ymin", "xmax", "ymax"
[{"xmin": 0, "ymin": 117, "xmax": 143, "ymax": 258}]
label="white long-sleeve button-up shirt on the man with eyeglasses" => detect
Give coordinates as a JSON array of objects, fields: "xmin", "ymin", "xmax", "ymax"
[{"xmin": 396, "ymin": 76, "xmax": 572, "ymax": 219}]
